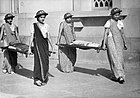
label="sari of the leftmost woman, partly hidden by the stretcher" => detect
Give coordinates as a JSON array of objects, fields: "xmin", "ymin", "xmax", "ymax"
[{"xmin": 2, "ymin": 23, "xmax": 17, "ymax": 73}]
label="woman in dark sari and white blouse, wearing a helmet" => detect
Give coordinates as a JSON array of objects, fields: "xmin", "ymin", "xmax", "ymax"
[{"xmin": 28, "ymin": 10, "xmax": 53, "ymax": 86}]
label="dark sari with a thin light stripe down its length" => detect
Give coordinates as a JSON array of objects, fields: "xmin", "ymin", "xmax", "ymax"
[{"xmin": 33, "ymin": 23, "xmax": 49, "ymax": 81}]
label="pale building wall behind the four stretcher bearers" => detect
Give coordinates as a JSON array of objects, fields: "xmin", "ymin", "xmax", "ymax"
[{"xmin": 0, "ymin": 0, "xmax": 140, "ymax": 61}]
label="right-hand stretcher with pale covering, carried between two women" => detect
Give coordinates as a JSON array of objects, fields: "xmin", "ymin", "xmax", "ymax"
[{"xmin": 58, "ymin": 40, "xmax": 100, "ymax": 50}]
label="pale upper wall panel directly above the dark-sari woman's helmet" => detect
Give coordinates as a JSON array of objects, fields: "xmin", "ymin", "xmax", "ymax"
[{"xmin": 19, "ymin": 0, "xmax": 73, "ymax": 13}]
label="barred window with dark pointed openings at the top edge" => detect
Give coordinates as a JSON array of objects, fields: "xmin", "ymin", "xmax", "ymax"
[{"xmin": 92, "ymin": 0, "xmax": 112, "ymax": 9}]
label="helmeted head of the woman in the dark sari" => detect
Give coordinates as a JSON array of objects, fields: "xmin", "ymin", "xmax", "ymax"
[{"xmin": 35, "ymin": 10, "xmax": 48, "ymax": 24}]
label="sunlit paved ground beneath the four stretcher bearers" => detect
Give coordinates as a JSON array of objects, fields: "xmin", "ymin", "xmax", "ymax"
[{"xmin": 0, "ymin": 53, "xmax": 140, "ymax": 98}]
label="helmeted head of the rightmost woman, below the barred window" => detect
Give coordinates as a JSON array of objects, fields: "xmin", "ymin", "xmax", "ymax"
[{"xmin": 111, "ymin": 8, "xmax": 122, "ymax": 21}]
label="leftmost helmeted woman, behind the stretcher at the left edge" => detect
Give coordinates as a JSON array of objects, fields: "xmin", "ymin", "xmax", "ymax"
[{"xmin": 0, "ymin": 13, "xmax": 20, "ymax": 74}]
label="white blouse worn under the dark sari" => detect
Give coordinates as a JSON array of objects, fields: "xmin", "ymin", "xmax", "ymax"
[{"xmin": 31, "ymin": 23, "xmax": 49, "ymax": 38}]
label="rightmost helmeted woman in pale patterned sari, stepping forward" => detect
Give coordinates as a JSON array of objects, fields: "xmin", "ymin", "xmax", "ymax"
[{"xmin": 101, "ymin": 8, "xmax": 127, "ymax": 84}]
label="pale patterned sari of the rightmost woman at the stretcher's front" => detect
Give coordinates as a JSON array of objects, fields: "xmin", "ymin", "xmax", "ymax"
[{"xmin": 106, "ymin": 20, "xmax": 125, "ymax": 79}]
